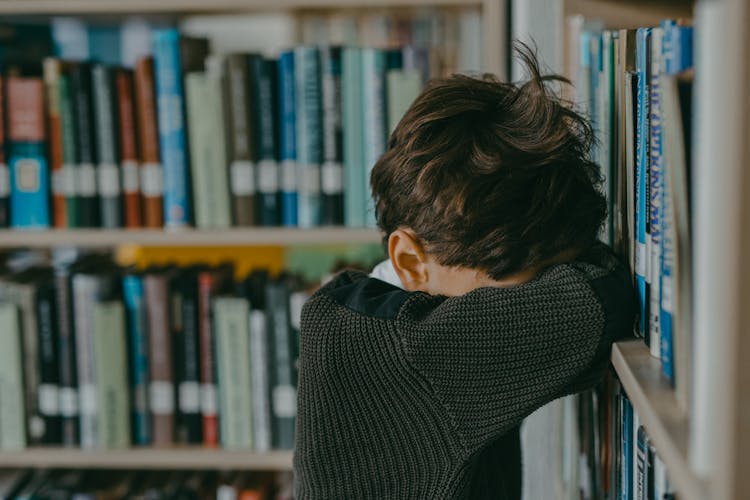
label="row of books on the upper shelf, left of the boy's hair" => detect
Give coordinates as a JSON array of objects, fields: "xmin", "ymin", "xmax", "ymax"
[{"xmin": 0, "ymin": 11, "xmax": 482, "ymax": 228}]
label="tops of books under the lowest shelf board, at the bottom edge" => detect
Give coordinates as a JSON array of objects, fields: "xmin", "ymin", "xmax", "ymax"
[{"xmin": 0, "ymin": 469, "xmax": 292, "ymax": 500}]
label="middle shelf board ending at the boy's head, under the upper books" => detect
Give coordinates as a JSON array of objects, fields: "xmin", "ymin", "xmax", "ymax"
[{"xmin": 0, "ymin": 227, "xmax": 381, "ymax": 248}]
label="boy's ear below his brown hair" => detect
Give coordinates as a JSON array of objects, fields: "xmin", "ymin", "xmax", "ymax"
[{"xmin": 388, "ymin": 229, "xmax": 429, "ymax": 292}]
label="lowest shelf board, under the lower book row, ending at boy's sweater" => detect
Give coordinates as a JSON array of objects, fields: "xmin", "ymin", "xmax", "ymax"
[{"xmin": 0, "ymin": 447, "xmax": 292, "ymax": 471}]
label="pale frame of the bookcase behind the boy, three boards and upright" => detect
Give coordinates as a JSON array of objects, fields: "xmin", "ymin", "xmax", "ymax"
[{"xmin": 0, "ymin": 0, "xmax": 507, "ymax": 486}]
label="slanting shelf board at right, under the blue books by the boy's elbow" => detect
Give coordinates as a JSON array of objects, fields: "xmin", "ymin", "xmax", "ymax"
[{"xmin": 612, "ymin": 340, "xmax": 708, "ymax": 500}]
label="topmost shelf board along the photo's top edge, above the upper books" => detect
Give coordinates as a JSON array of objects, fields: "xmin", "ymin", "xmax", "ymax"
[{"xmin": 0, "ymin": 0, "xmax": 483, "ymax": 14}]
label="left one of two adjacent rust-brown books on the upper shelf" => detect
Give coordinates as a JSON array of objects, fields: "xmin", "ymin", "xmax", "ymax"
[{"xmin": 115, "ymin": 69, "xmax": 142, "ymax": 228}]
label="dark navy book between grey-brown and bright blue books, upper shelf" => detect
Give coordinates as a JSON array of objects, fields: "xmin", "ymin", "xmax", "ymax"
[{"xmin": 250, "ymin": 56, "xmax": 281, "ymax": 226}]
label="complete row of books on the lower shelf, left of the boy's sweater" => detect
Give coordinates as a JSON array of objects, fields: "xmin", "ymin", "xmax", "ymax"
[{"xmin": 0, "ymin": 254, "xmax": 308, "ymax": 451}]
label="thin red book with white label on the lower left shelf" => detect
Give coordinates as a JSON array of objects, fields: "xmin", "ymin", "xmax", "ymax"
[{"xmin": 198, "ymin": 272, "xmax": 219, "ymax": 446}]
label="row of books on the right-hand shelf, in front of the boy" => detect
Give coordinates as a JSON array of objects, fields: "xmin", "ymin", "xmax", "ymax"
[{"xmin": 570, "ymin": 18, "xmax": 693, "ymax": 407}]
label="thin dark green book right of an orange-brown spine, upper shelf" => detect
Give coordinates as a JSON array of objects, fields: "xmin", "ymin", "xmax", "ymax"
[{"xmin": 59, "ymin": 73, "xmax": 79, "ymax": 227}]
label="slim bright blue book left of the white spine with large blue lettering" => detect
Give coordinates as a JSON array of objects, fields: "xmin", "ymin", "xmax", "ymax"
[{"xmin": 635, "ymin": 28, "xmax": 651, "ymax": 337}]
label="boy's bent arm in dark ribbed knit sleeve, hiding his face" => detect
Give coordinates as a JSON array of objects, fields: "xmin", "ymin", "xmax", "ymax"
[{"xmin": 397, "ymin": 264, "xmax": 634, "ymax": 452}]
